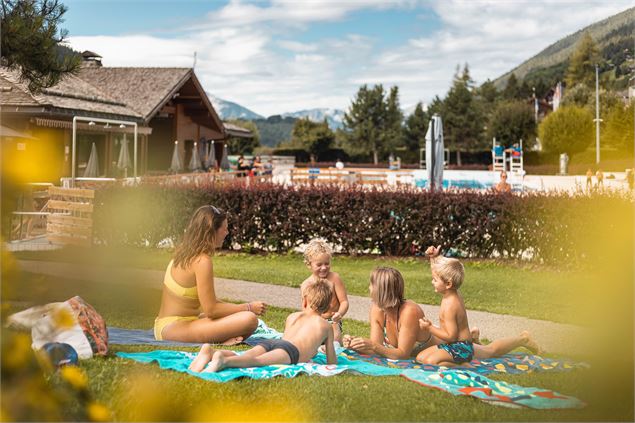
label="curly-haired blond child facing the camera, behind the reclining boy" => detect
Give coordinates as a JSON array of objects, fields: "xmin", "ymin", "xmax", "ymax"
[{"xmin": 302, "ymin": 239, "xmax": 348, "ymax": 347}]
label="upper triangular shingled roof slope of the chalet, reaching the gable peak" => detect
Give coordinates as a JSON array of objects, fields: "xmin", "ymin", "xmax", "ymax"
[{"xmin": 78, "ymin": 67, "xmax": 192, "ymax": 120}]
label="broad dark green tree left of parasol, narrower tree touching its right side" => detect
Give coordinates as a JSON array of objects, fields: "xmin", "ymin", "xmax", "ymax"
[{"xmin": 344, "ymin": 84, "xmax": 386, "ymax": 164}]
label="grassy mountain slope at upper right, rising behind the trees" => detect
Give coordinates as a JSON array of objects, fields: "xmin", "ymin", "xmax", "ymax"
[{"xmin": 494, "ymin": 7, "xmax": 635, "ymax": 90}]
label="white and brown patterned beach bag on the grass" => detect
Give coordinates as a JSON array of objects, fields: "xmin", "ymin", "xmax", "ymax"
[{"xmin": 8, "ymin": 296, "xmax": 108, "ymax": 360}]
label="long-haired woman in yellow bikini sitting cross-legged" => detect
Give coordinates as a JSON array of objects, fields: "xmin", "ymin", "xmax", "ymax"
[{"xmin": 154, "ymin": 206, "xmax": 266, "ymax": 344}]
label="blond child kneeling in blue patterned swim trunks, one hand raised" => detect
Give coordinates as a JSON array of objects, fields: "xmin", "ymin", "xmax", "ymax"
[{"xmin": 416, "ymin": 246, "xmax": 542, "ymax": 366}]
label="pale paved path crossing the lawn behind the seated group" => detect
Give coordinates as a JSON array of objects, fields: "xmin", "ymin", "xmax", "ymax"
[{"xmin": 19, "ymin": 260, "xmax": 592, "ymax": 355}]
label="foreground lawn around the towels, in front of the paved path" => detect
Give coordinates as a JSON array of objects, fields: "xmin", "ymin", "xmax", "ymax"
[{"xmin": 2, "ymin": 270, "xmax": 633, "ymax": 422}]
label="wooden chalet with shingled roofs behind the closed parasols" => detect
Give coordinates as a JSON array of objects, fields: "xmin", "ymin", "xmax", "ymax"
[{"xmin": 0, "ymin": 51, "xmax": 234, "ymax": 182}]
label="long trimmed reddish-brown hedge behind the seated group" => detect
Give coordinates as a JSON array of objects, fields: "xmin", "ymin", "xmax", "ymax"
[{"xmin": 94, "ymin": 184, "xmax": 633, "ymax": 261}]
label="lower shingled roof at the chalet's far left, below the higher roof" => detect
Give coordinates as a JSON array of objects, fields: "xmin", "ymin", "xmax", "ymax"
[{"xmin": 0, "ymin": 67, "xmax": 141, "ymax": 119}]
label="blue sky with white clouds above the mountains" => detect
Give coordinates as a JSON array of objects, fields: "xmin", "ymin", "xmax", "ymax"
[{"xmin": 66, "ymin": 0, "xmax": 633, "ymax": 116}]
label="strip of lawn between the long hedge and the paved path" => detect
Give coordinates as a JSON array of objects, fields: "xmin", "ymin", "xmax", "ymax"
[{"xmin": 16, "ymin": 247, "xmax": 597, "ymax": 323}]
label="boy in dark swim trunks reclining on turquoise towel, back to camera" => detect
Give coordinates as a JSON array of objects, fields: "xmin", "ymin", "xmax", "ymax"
[{"xmin": 189, "ymin": 279, "xmax": 337, "ymax": 372}]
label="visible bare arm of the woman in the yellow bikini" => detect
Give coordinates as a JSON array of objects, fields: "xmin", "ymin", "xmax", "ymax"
[{"xmin": 192, "ymin": 256, "xmax": 256, "ymax": 319}]
